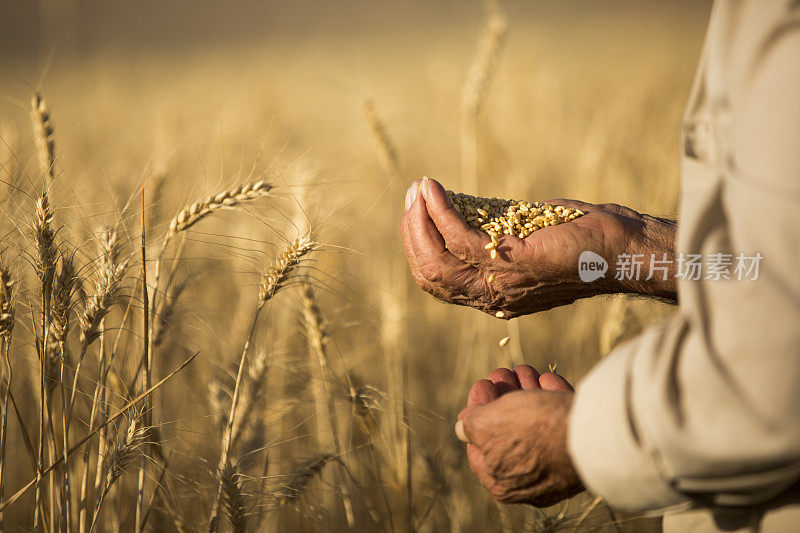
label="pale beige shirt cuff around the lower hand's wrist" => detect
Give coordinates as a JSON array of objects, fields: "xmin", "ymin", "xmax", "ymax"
[{"xmin": 568, "ymin": 338, "xmax": 688, "ymax": 511}]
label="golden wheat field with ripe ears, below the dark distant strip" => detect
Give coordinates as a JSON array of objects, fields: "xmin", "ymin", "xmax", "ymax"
[{"xmin": 0, "ymin": 2, "xmax": 708, "ymax": 532}]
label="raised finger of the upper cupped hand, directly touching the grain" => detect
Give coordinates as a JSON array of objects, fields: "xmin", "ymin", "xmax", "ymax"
[{"xmin": 420, "ymin": 178, "xmax": 491, "ymax": 264}]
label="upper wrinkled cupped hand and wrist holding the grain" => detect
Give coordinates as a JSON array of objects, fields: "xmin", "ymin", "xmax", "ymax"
[{"xmin": 402, "ymin": 179, "xmax": 675, "ymax": 318}]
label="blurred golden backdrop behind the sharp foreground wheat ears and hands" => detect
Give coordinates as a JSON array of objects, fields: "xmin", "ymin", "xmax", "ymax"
[{"xmin": 0, "ymin": 0, "xmax": 711, "ymax": 531}]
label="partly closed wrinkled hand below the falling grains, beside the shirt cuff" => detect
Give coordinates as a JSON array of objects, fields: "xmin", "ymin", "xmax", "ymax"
[{"xmin": 456, "ymin": 365, "xmax": 583, "ymax": 507}]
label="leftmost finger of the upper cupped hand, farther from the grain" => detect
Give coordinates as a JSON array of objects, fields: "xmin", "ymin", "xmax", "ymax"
[{"xmin": 406, "ymin": 189, "xmax": 464, "ymax": 284}]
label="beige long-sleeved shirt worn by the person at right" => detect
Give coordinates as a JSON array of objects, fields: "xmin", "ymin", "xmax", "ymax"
[{"xmin": 569, "ymin": 0, "xmax": 800, "ymax": 531}]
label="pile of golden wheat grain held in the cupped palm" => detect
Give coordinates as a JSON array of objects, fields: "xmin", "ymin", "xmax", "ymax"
[{"xmin": 447, "ymin": 191, "xmax": 584, "ymax": 259}]
